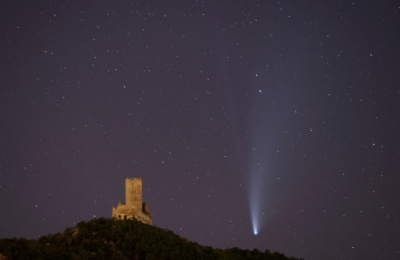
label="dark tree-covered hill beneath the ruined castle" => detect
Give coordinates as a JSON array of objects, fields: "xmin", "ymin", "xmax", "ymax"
[{"xmin": 0, "ymin": 218, "xmax": 302, "ymax": 260}]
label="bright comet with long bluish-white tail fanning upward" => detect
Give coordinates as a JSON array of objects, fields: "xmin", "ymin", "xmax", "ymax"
[{"xmin": 244, "ymin": 85, "xmax": 277, "ymax": 236}]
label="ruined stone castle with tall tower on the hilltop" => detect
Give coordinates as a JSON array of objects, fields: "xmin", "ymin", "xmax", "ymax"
[{"xmin": 112, "ymin": 178, "xmax": 152, "ymax": 225}]
